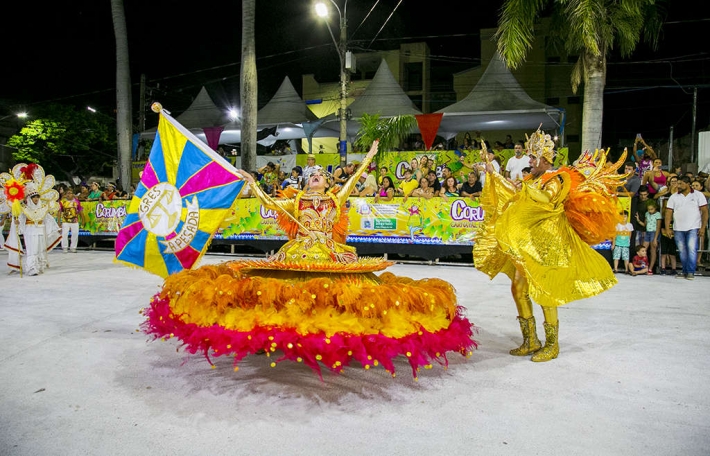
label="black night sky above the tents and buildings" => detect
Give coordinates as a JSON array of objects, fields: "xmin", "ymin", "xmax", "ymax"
[{"xmin": 0, "ymin": 0, "xmax": 710, "ymax": 149}]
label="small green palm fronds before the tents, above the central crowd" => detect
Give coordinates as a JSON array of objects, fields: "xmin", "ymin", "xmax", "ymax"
[{"xmin": 355, "ymin": 114, "xmax": 417, "ymax": 152}]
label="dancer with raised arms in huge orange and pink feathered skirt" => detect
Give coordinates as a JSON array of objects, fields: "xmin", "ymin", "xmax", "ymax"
[{"xmin": 143, "ymin": 143, "xmax": 476, "ymax": 378}]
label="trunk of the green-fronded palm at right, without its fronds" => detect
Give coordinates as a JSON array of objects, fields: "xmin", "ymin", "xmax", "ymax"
[{"xmin": 582, "ymin": 50, "xmax": 606, "ymax": 152}]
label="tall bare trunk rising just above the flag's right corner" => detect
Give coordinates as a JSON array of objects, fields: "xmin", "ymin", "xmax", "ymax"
[{"xmin": 240, "ymin": 0, "xmax": 259, "ymax": 171}]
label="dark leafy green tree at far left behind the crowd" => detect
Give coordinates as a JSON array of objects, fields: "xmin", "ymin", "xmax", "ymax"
[{"xmin": 7, "ymin": 105, "xmax": 116, "ymax": 180}]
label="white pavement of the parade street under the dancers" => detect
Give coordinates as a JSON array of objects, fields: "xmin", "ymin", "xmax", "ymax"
[{"xmin": 0, "ymin": 251, "xmax": 710, "ymax": 456}]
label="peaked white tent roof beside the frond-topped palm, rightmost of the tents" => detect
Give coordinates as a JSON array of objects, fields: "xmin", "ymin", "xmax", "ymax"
[{"xmin": 437, "ymin": 52, "xmax": 564, "ymax": 136}]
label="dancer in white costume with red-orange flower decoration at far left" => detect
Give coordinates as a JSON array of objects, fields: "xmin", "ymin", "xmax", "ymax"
[{"xmin": 0, "ymin": 163, "xmax": 61, "ymax": 275}]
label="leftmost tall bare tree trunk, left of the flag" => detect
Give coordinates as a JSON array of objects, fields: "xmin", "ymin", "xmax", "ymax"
[{"xmin": 111, "ymin": 0, "xmax": 133, "ymax": 191}]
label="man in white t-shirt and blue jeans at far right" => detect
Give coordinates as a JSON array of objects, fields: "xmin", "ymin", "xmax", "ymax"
[{"xmin": 665, "ymin": 176, "xmax": 708, "ymax": 280}]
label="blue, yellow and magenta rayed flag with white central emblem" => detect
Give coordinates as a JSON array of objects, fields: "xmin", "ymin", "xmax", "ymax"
[{"xmin": 116, "ymin": 103, "xmax": 244, "ymax": 277}]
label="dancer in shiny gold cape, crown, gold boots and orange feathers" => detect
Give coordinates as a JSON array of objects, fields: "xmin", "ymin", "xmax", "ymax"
[{"xmin": 473, "ymin": 129, "xmax": 626, "ymax": 362}]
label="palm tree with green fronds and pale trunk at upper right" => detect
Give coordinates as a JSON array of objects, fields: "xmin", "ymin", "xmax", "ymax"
[{"xmin": 495, "ymin": 0, "xmax": 662, "ymax": 151}]
